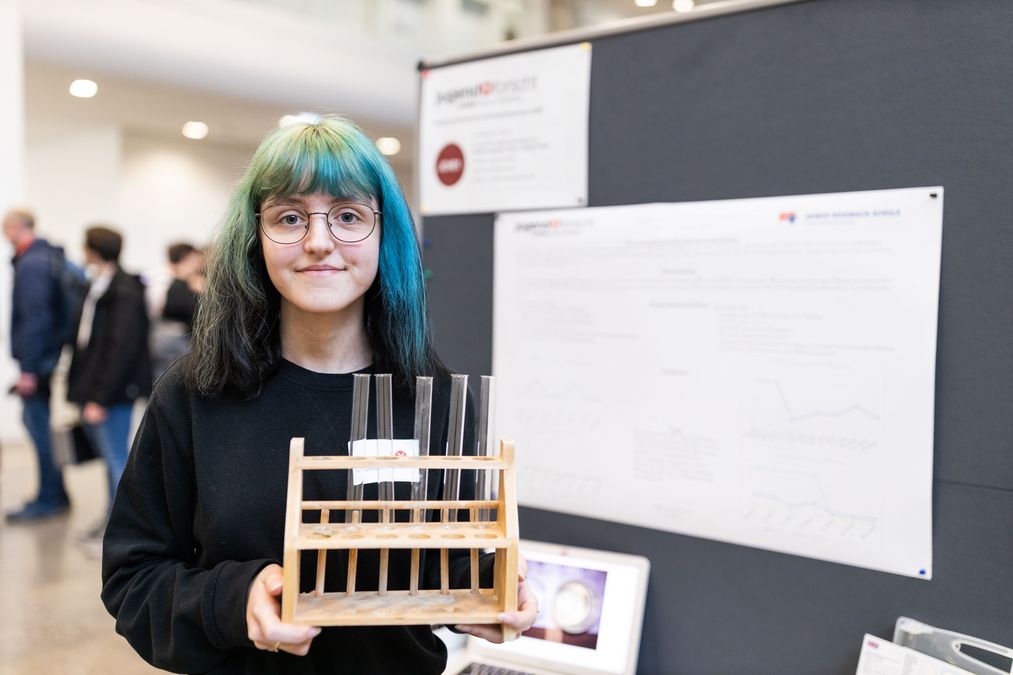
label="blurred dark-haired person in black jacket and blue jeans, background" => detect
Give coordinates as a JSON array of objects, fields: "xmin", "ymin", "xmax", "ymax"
[{"xmin": 67, "ymin": 226, "xmax": 151, "ymax": 516}]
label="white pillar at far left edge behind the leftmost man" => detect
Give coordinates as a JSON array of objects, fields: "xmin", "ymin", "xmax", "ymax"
[{"xmin": 0, "ymin": 2, "xmax": 25, "ymax": 442}]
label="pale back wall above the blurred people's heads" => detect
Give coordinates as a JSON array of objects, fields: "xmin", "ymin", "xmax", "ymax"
[{"xmin": 24, "ymin": 127, "xmax": 252, "ymax": 273}]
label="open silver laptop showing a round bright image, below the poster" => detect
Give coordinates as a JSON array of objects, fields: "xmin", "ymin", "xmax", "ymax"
[{"xmin": 444, "ymin": 540, "xmax": 650, "ymax": 675}]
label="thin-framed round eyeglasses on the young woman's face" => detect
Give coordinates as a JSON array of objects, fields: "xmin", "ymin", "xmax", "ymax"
[{"xmin": 255, "ymin": 202, "xmax": 380, "ymax": 244}]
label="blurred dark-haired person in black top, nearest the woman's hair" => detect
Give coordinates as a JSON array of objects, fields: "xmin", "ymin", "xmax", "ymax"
[{"xmin": 148, "ymin": 242, "xmax": 204, "ymax": 379}]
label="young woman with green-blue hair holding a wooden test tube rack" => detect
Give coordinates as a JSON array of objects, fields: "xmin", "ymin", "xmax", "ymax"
[{"xmin": 102, "ymin": 118, "xmax": 537, "ymax": 674}]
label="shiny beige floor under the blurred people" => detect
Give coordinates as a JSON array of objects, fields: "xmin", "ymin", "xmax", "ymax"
[{"xmin": 0, "ymin": 445, "xmax": 162, "ymax": 675}]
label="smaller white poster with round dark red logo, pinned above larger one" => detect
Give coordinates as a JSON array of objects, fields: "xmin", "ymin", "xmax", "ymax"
[{"xmin": 418, "ymin": 44, "xmax": 591, "ymax": 215}]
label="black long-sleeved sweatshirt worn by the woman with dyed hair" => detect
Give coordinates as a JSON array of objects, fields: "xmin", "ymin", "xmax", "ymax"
[{"xmin": 102, "ymin": 362, "xmax": 491, "ymax": 675}]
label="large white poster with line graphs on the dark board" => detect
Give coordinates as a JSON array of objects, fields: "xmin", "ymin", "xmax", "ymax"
[{"xmin": 493, "ymin": 188, "xmax": 943, "ymax": 579}]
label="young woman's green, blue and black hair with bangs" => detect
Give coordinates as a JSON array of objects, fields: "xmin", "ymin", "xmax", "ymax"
[{"xmin": 185, "ymin": 117, "xmax": 444, "ymax": 396}]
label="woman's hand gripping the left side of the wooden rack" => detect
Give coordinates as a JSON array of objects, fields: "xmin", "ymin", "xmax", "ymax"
[{"xmin": 246, "ymin": 565, "xmax": 320, "ymax": 656}]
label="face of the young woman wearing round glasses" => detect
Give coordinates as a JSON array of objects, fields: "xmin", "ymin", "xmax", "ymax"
[{"xmin": 259, "ymin": 193, "xmax": 381, "ymax": 314}]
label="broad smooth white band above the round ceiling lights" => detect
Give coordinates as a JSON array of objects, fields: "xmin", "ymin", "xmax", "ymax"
[{"xmin": 21, "ymin": 0, "xmax": 418, "ymax": 128}]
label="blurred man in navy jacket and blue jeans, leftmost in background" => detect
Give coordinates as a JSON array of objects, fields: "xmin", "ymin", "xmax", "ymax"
[{"xmin": 3, "ymin": 210, "xmax": 70, "ymax": 522}]
